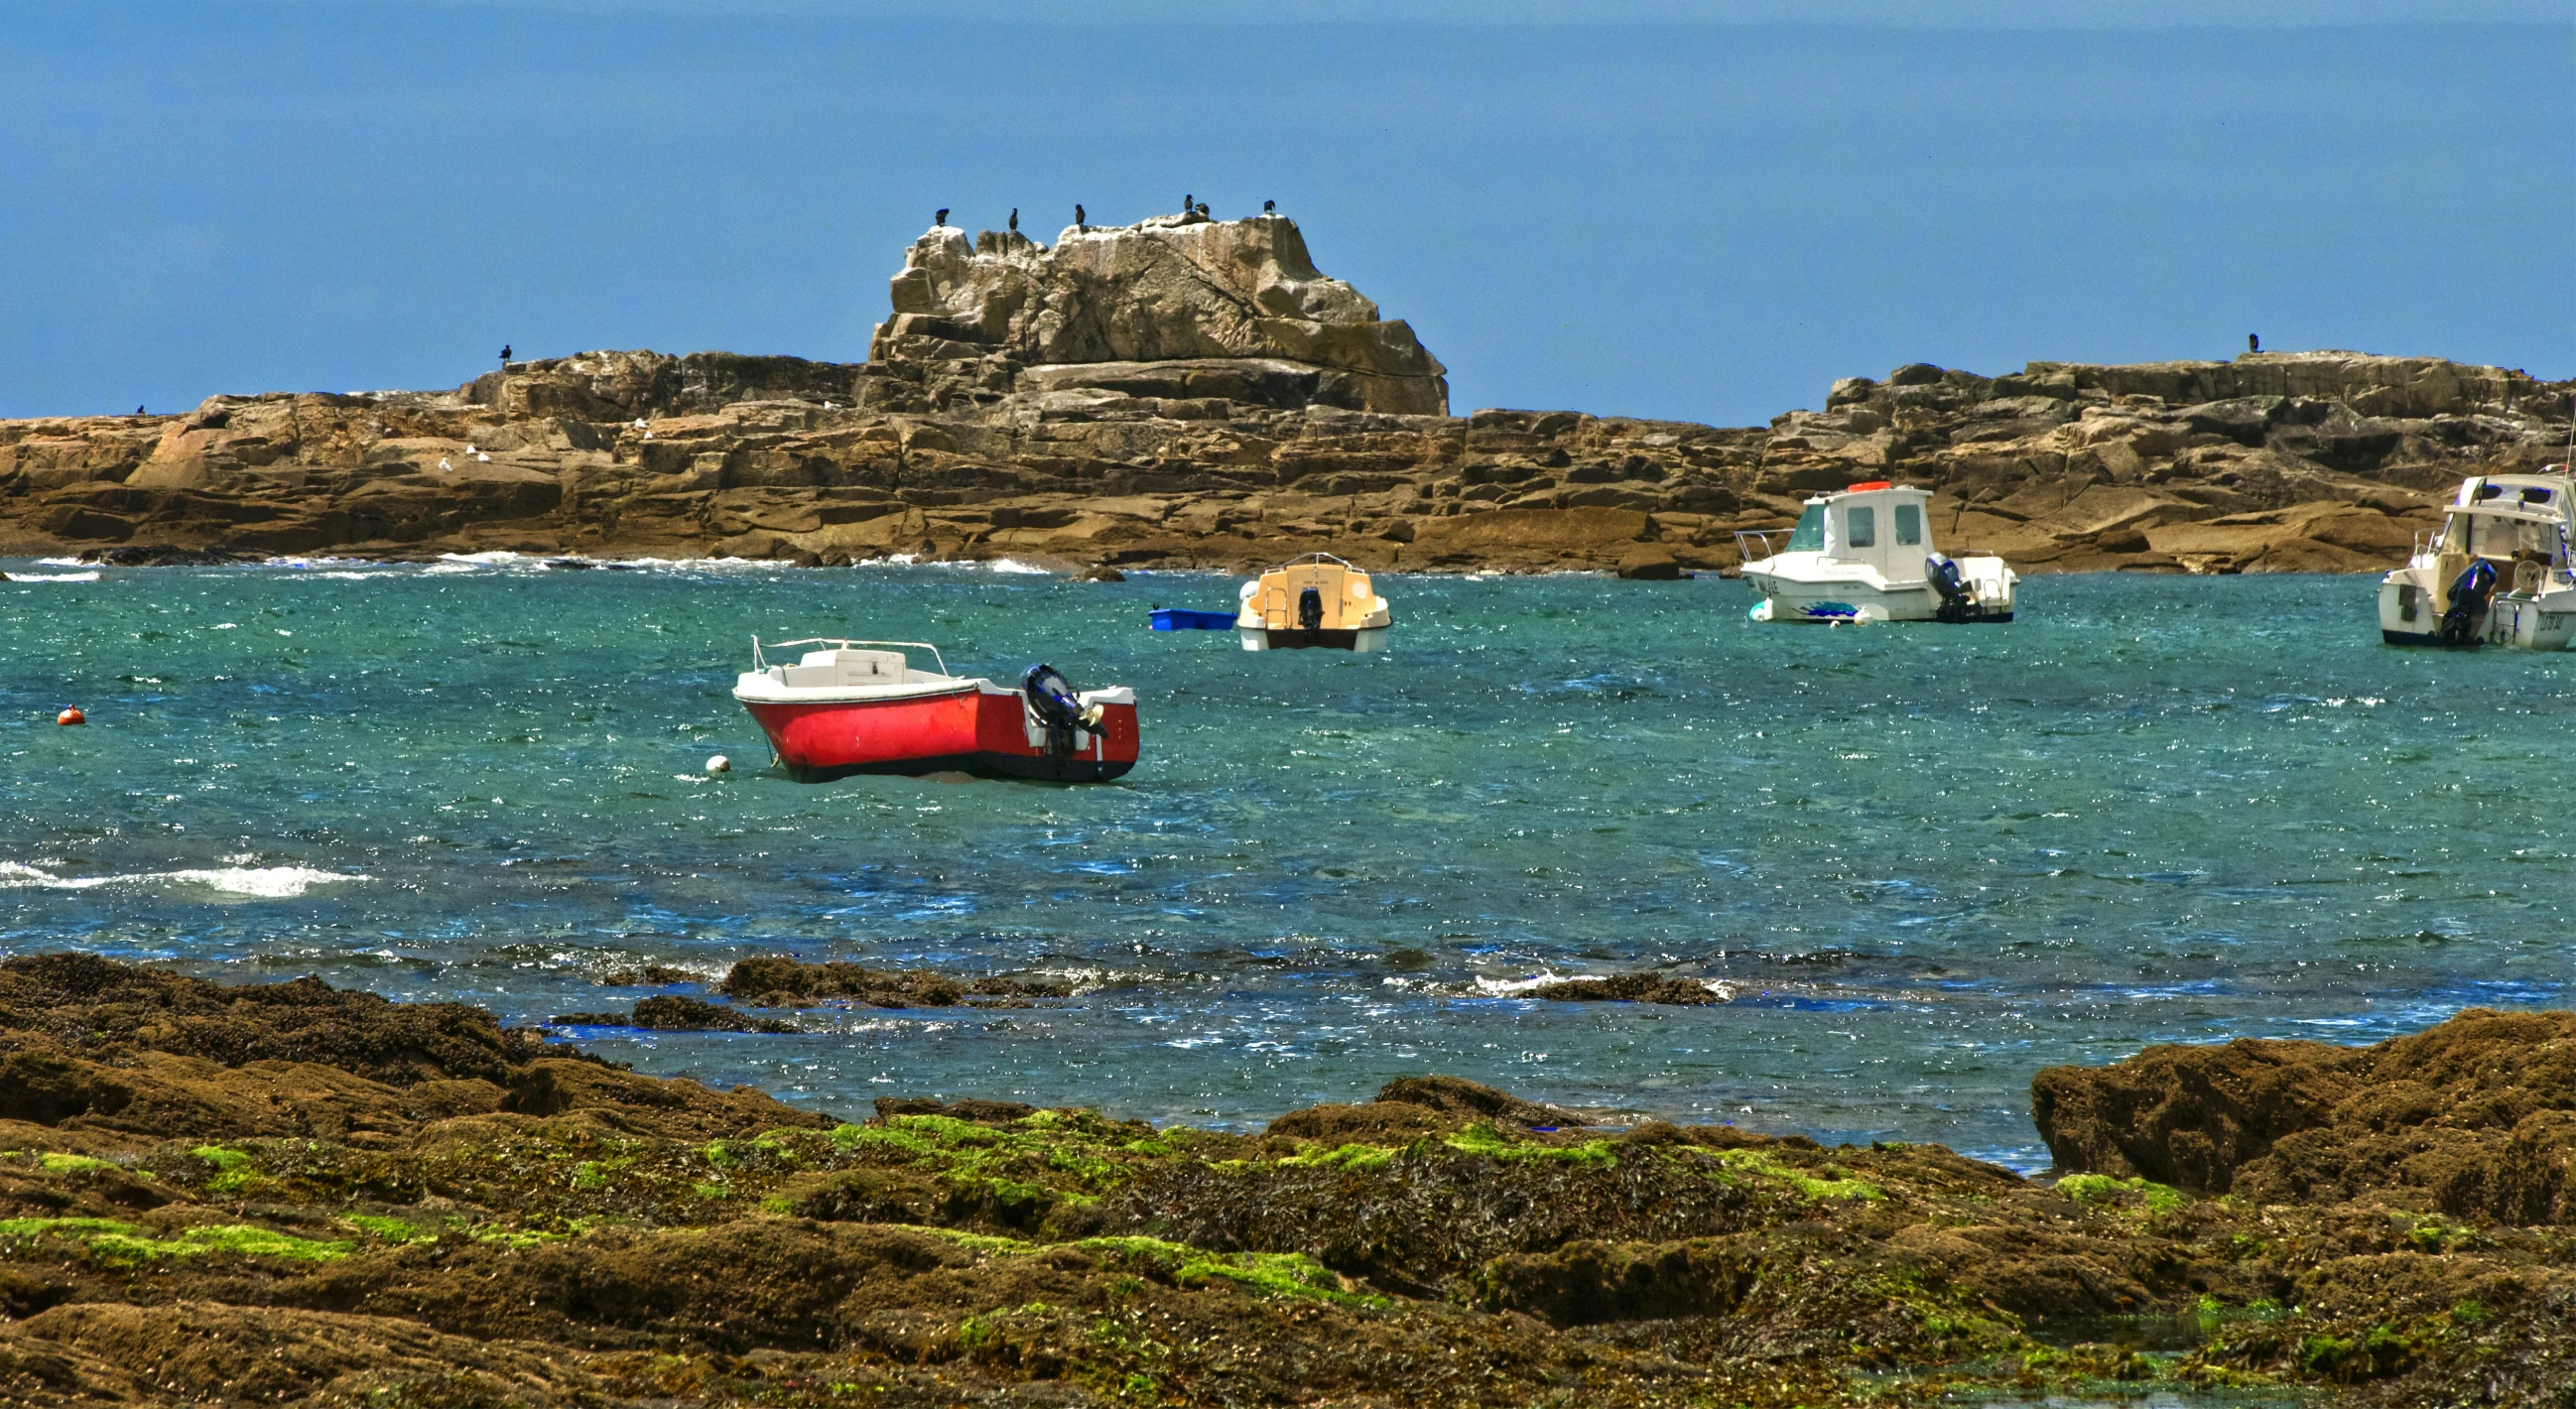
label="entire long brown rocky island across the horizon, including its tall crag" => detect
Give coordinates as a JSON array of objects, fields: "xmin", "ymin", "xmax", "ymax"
[{"xmin": 0, "ymin": 213, "xmax": 2576, "ymax": 576}]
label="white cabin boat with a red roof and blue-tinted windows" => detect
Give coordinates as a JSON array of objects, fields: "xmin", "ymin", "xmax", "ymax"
[{"xmin": 1737, "ymin": 479, "xmax": 2019, "ymax": 623}]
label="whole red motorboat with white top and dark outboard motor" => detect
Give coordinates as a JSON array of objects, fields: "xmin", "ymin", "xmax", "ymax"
[{"xmin": 734, "ymin": 636, "xmax": 1136, "ymax": 783}]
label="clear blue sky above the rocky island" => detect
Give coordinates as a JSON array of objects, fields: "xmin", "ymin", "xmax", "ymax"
[{"xmin": 0, "ymin": 0, "xmax": 2576, "ymax": 425}]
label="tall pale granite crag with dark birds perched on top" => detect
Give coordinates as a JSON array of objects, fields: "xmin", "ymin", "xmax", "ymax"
[{"xmin": 863, "ymin": 216, "xmax": 1448, "ymax": 415}]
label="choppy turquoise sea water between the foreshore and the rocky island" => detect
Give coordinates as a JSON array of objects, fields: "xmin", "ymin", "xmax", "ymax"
[{"xmin": 0, "ymin": 559, "xmax": 2576, "ymax": 1167}]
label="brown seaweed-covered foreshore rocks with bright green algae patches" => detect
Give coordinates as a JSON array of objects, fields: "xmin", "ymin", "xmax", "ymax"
[{"xmin": 0, "ymin": 956, "xmax": 2576, "ymax": 1409}]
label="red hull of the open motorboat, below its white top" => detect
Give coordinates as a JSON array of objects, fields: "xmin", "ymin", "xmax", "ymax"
[{"xmin": 742, "ymin": 686, "xmax": 1136, "ymax": 783}]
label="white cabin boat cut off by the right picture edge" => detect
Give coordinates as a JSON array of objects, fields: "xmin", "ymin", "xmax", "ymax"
[{"xmin": 2381, "ymin": 463, "xmax": 2576, "ymax": 652}]
